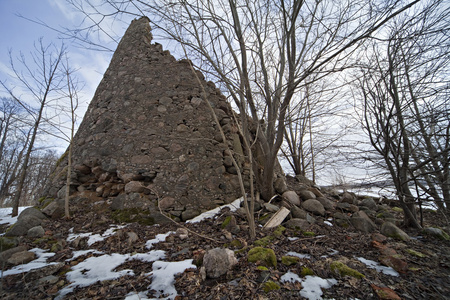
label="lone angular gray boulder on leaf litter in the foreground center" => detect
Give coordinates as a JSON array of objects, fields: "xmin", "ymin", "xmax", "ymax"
[{"xmin": 203, "ymin": 248, "xmax": 237, "ymax": 278}]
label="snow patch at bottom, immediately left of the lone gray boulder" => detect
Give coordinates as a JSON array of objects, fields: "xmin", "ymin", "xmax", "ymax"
[{"xmin": 148, "ymin": 259, "xmax": 197, "ymax": 299}]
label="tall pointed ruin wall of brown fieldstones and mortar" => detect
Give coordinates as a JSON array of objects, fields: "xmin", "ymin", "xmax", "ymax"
[{"xmin": 44, "ymin": 17, "xmax": 268, "ymax": 220}]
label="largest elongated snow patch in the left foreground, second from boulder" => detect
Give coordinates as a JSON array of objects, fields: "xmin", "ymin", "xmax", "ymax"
[{"xmin": 56, "ymin": 250, "xmax": 165, "ymax": 299}]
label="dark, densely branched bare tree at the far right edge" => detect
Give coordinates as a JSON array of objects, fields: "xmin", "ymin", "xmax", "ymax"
[{"xmin": 359, "ymin": 1, "xmax": 450, "ymax": 227}]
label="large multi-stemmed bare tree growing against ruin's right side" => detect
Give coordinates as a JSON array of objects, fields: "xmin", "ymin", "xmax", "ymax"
[{"xmin": 61, "ymin": 0, "xmax": 419, "ymax": 200}]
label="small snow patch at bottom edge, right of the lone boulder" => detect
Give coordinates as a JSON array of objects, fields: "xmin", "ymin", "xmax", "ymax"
[{"xmin": 280, "ymin": 271, "xmax": 337, "ymax": 300}]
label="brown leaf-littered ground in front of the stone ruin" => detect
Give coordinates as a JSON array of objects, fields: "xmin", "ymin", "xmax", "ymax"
[{"xmin": 0, "ymin": 197, "xmax": 450, "ymax": 300}]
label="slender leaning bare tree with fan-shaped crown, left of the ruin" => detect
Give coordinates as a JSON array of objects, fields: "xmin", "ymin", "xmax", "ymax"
[{"xmin": 0, "ymin": 38, "xmax": 65, "ymax": 216}]
